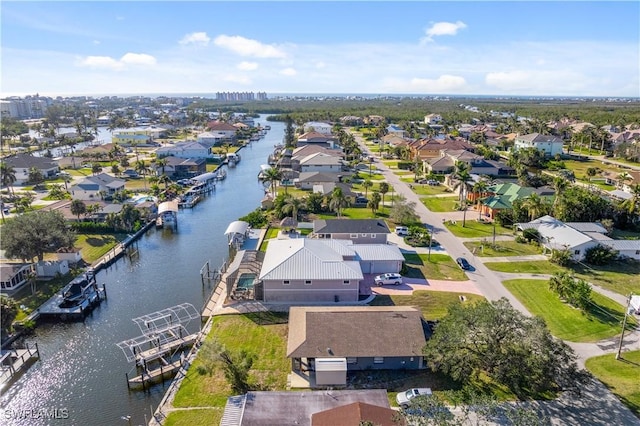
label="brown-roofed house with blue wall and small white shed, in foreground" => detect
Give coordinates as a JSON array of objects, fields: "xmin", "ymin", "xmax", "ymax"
[{"xmin": 287, "ymin": 306, "xmax": 428, "ymax": 385}]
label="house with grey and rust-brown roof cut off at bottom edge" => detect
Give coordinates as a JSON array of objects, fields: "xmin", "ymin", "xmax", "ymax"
[{"xmin": 220, "ymin": 389, "xmax": 396, "ymax": 426}]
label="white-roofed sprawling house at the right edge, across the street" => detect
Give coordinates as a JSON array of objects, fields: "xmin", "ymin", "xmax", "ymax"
[{"xmin": 516, "ymin": 215, "xmax": 640, "ymax": 261}]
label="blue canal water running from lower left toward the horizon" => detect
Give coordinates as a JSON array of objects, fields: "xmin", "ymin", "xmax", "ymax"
[{"xmin": 0, "ymin": 115, "xmax": 284, "ymax": 426}]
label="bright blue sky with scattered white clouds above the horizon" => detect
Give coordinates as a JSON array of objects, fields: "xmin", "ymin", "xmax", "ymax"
[{"xmin": 0, "ymin": 1, "xmax": 640, "ymax": 97}]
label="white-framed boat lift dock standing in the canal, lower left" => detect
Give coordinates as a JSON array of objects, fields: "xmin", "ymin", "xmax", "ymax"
[{"xmin": 117, "ymin": 303, "xmax": 200, "ymax": 389}]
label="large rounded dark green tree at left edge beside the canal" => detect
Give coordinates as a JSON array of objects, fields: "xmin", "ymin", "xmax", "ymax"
[{"xmin": 0, "ymin": 211, "xmax": 75, "ymax": 261}]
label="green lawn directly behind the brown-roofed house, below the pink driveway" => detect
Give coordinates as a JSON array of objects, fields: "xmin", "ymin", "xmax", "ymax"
[{"xmin": 369, "ymin": 290, "xmax": 484, "ymax": 321}]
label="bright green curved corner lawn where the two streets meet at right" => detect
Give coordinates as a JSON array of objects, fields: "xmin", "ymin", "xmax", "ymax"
[{"xmin": 503, "ymin": 280, "xmax": 635, "ymax": 342}]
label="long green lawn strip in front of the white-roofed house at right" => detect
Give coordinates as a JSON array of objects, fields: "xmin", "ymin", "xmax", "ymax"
[{"xmin": 485, "ymin": 260, "xmax": 640, "ymax": 296}]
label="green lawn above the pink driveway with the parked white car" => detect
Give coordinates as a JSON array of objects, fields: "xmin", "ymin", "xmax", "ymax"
[{"xmin": 404, "ymin": 253, "xmax": 469, "ymax": 281}]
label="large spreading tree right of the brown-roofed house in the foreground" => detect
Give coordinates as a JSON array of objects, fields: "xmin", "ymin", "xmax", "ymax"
[{"xmin": 424, "ymin": 298, "xmax": 585, "ymax": 398}]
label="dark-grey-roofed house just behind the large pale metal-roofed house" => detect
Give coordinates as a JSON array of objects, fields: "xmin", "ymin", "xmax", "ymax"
[{"xmin": 310, "ymin": 219, "xmax": 390, "ymax": 244}]
